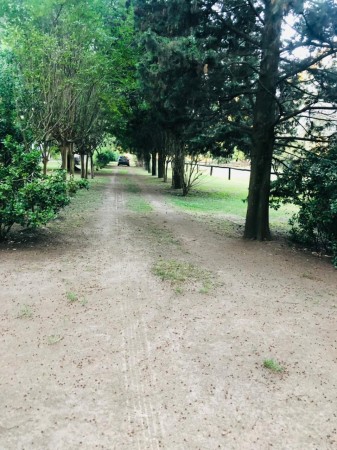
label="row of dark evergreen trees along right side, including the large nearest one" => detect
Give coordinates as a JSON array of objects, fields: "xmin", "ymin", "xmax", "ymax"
[{"xmin": 122, "ymin": 0, "xmax": 337, "ymax": 248}]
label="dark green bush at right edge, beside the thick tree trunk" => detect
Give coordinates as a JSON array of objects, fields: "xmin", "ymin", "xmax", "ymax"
[{"xmin": 272, "ymin": 145, "xmax": 337, "ymax": 267}]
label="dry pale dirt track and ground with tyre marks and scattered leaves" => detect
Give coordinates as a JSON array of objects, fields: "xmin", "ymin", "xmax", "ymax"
[{"xmin": 0, "ymin": 168, "xmax": 337, "ymax": 450}]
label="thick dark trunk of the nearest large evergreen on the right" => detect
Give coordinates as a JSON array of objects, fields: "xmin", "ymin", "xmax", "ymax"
[{"xmin": 244, "ymin": 0, "xmax": 284, "ymax": 240}]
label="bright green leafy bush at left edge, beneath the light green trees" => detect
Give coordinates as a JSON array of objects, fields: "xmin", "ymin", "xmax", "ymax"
[{"xmin": 0, "ymin": 138, "xmax": 78, "ymax": 240}]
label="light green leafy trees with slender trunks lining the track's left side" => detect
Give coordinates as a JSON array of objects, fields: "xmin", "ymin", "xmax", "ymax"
[{"xmin": 0, "ymin": 0, "xmax": 135, "ymax": 177}]
